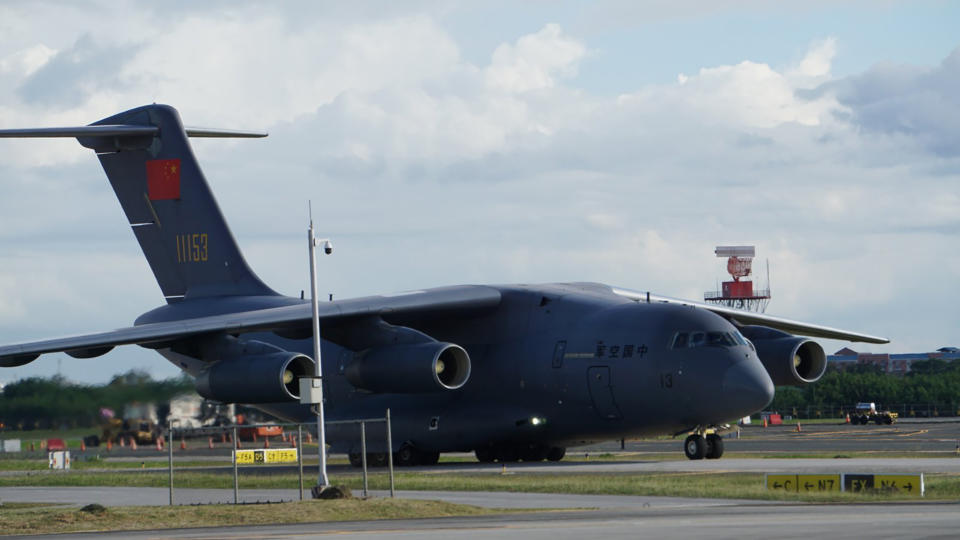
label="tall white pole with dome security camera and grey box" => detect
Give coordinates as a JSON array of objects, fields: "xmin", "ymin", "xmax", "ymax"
[{"xmin": 300, "ymin": 206, "xmax": 333, "ymax": 498}]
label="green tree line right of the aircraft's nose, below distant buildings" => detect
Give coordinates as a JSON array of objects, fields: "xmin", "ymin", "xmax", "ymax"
[{"xmin": 768, "ymin": 358, "xmax": 960, "ymax": 416}]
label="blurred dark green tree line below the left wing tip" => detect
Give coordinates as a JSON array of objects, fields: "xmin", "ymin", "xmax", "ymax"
[{"xmin": 0, "ymin": 370, "xmax": 195, "ymax": 430}]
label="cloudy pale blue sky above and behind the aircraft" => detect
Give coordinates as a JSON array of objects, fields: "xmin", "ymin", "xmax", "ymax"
[{"xmin": 0, "ymin": 0, "xmax": 960, "ymax": 382}]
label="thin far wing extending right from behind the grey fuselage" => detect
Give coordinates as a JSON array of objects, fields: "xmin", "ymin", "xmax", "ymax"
[{"xmin": 613, "ymin": 288, "xmax": 890, "ymax": 343}]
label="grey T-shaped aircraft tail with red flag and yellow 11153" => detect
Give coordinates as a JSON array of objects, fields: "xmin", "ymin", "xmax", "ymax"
[{"xmin": 0, "ymin": 105, "xmax": 277, "ymax": 302}]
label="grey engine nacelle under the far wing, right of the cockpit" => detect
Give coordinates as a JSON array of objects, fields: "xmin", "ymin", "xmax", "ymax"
[{"xmin": 740, "ymin": 326, "xmax": 827, "ymax": 386}]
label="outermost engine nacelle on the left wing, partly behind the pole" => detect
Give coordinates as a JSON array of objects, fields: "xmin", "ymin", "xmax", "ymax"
[{"xmin": 196, "ymin": 352, "xmax": 314, "ymax": 403}]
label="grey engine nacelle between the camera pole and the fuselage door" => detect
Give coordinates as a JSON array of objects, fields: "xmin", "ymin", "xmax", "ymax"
[{"xmin": 344, "ymin": 342, "xmax": 470, "ymax": 394}]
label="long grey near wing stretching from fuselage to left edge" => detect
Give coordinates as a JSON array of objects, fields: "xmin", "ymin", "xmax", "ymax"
[{"xmin": 0, "ymin": 285, "xmax": 500, "ymax": 367}]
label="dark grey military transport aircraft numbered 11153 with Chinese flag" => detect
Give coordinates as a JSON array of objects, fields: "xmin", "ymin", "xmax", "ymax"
[{"xmin": 0, "ymin": 105, "xmax": 887, "ymax": 464}]
